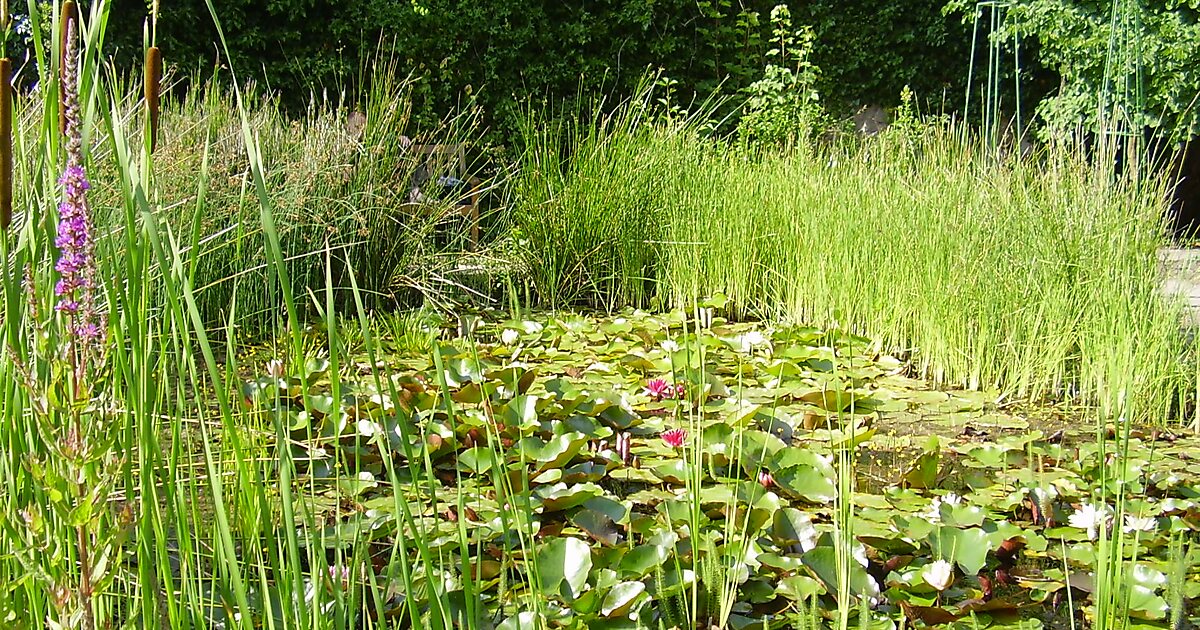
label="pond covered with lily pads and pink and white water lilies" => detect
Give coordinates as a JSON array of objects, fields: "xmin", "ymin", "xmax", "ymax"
[{"xmin": 242, "ymin": 312, "xmax": 1200, "ymax": 629}]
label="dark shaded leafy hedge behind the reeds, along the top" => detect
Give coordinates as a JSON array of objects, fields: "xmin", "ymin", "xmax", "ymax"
[{"xmin": 96, "ymin": 0, "xmax": 970, "ymax": 132}]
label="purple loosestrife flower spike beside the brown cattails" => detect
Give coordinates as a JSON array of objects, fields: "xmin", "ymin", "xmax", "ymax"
[{"xmin": 54, "ymin": 20, "xmax": 103, "ymax": 349}]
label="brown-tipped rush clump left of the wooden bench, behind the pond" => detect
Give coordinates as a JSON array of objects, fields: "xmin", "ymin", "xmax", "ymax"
[{"xmin": 84, "ymin": 56, "xmax": 489, "ymax": 334}]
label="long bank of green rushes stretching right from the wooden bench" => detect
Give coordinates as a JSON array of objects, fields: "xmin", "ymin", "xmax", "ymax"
[{"xmin": 516, "ymin": 97, "xmax": 1190, "ymax": 419}]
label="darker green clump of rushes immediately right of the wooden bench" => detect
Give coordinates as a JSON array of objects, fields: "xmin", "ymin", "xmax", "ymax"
[{"xmin": 511, "ymin": 90, "xmax": 696, "ymax": 310}]
